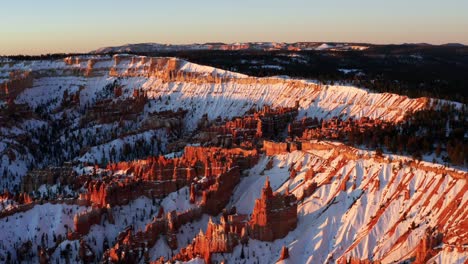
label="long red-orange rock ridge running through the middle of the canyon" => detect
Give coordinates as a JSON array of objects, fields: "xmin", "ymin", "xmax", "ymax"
[{"xmin": 80, "ymin": 146, "xmax": 258, "ymax": 207}]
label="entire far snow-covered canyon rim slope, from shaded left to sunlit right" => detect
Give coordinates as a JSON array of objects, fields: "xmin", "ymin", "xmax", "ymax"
[{"xmin": 0, "ymin": 55, "xmax": 428, "ymax": 128}]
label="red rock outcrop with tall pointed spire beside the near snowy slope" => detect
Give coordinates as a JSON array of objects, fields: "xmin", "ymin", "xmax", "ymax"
[{"xmin": 174, "ymin": 178, "xmax": 297, "ymax": 263}]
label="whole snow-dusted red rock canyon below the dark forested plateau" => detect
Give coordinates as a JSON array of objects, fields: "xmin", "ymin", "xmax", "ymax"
[{"xmin": 0, "ymin": 54, "xmax": 468, "ymax": 263}]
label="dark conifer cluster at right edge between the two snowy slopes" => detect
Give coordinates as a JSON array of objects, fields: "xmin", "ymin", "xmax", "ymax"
[{"xmin": 300, "ymin": 105, "xmax": 468, "ymax": 166}]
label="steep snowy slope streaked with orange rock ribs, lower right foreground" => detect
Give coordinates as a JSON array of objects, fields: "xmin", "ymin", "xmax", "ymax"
[{"xmin": 222, "ymin": 142, "xmax": 468, "ymax": 263}]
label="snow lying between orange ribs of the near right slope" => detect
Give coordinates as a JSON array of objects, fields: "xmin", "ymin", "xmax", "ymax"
[{"xmin": 225, "ymin": 144, "xmax": 468, "ymax": 263}]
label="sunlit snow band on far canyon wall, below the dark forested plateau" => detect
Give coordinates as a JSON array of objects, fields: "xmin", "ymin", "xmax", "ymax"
[{"xmin": 142, "ymin": 78, "xmax": 424, "ymax": 130}]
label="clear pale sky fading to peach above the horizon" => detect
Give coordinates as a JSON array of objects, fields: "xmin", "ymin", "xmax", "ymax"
[{"xmin": 0, "ymin": 0, "xmax": 468, "ymax": 55}]
